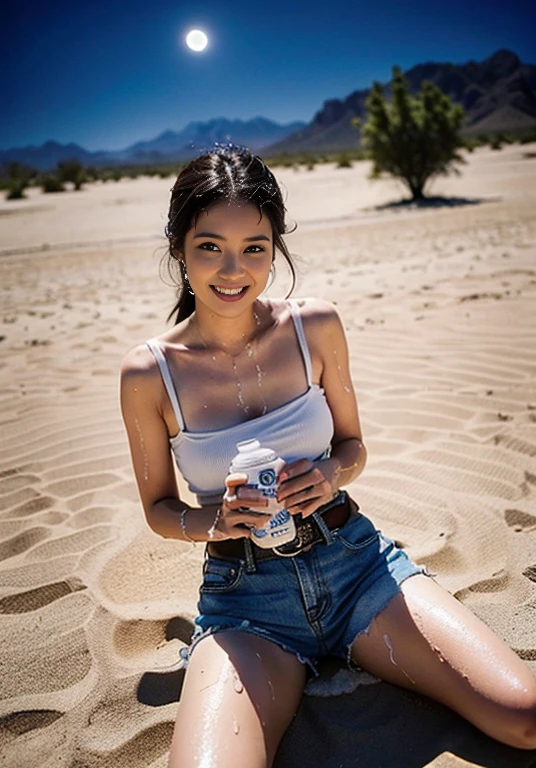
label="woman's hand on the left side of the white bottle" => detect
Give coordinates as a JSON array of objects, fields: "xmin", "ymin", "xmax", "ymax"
[{"xmin": 216, "ymin": 472, "xmax": 268, "ymax": 539}]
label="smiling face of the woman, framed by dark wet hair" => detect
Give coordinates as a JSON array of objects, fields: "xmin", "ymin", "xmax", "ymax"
[{"xmin": 184, "ymin": 202, "xmax": 274, "ymax": 315}]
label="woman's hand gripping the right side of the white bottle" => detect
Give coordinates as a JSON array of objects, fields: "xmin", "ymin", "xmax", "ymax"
[{"xmin": 277, "ymin": 458, "xmax": 341, "ymax": 517}]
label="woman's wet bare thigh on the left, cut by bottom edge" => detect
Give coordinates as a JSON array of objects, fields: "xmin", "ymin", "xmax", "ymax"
[{"xmin": 169, "ymin": 631, "xmax": 305, "ymax": 768}]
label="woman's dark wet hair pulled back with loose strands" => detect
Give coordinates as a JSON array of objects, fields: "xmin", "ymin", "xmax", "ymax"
[{"xmin": 165, "ymin": 145, "xmax": 296, "ymax": 323}]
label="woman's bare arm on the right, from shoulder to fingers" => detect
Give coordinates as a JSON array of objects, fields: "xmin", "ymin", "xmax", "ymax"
[{"xmin": 278, "ymin": 300, "xmax": 367, "ymax": 516}]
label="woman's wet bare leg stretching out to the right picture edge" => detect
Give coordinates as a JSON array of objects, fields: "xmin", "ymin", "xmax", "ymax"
[{"xmin": 352, "ymin": 574, "xmax": 536, "ymax": 749}]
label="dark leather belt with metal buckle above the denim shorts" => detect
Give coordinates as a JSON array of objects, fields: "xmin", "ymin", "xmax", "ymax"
[{"xmin": 207, "ymin": 491, "xmax": 359, "ymax": 560}]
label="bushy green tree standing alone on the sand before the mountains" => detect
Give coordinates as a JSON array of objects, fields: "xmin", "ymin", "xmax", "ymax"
[{"xmin": 354, "ymin": 67, "xmax": 465, "ymax": 200}]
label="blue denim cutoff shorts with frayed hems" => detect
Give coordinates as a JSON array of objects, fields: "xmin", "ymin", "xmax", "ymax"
[{"xmin": 181, "ymin": 512, "xmax": 426, "ymax": 675}]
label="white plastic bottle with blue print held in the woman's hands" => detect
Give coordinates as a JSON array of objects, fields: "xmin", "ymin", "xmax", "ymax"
[{"xmin": 229, "ymin": 440, "xmax": 296, "ymax": 549}]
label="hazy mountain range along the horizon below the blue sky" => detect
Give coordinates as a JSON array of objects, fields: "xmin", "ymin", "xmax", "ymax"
[{"xmin": 0, "ymin": 50, "xmax": 536, "ymax": 170}]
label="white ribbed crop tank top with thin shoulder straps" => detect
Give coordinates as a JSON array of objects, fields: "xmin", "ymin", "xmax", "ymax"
[{"xmin": 147, "ymin": 302, "xmax": 333, "ymax": 504}]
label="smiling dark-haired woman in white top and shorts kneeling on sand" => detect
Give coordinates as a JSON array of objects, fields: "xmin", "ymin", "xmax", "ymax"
[{"xmin": 121, "ymin": 149, "xmax": 536, "ymax": 768}]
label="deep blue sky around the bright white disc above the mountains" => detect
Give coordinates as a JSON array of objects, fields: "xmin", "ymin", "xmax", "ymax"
[{"xmin": 5, "ymin": 0, "xmax": 536, "ymax": 150}]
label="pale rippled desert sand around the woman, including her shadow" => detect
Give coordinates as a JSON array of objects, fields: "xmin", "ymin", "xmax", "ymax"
[{"xmin": 0, "ymin": 145, "xmax": 536, "ymax": 768}]
